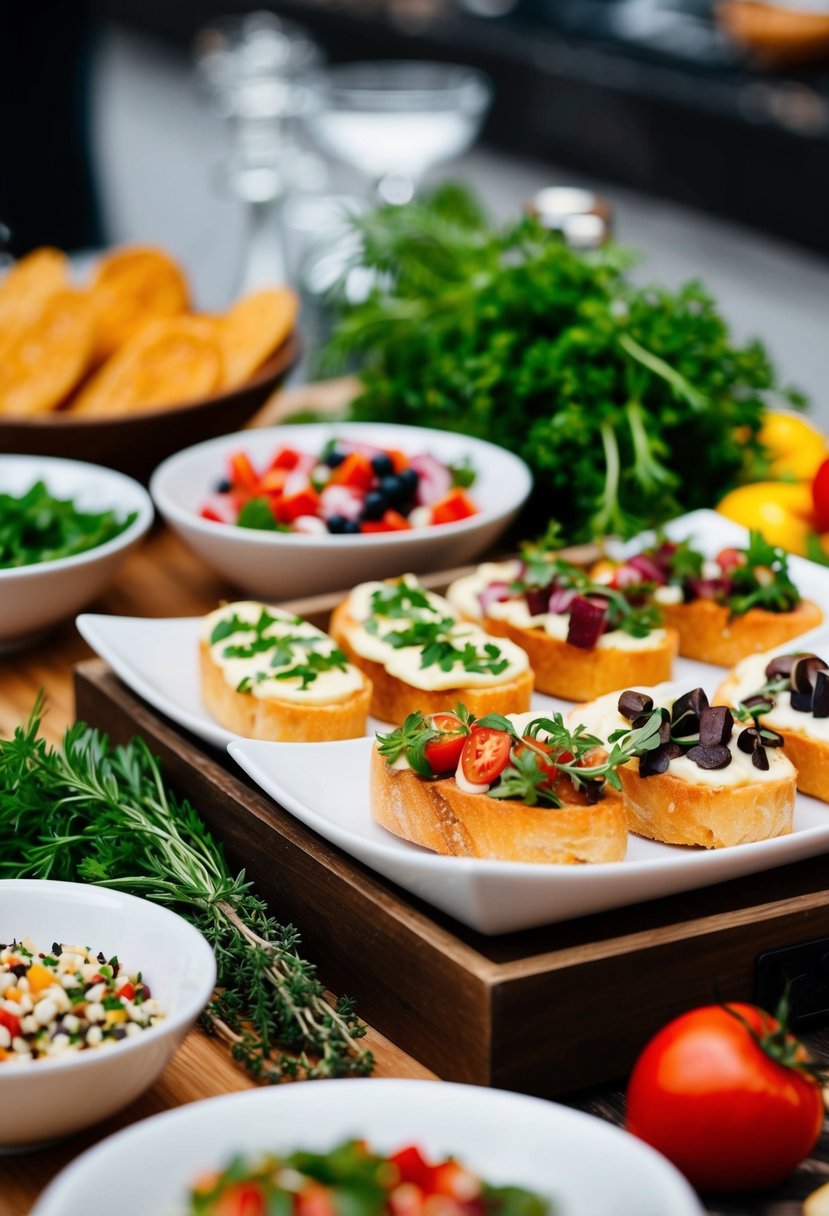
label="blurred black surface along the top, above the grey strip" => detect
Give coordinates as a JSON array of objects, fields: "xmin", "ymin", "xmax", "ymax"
[{"xmin": 97, "ymin": 0, "xmax": 829, "ymax": 252}]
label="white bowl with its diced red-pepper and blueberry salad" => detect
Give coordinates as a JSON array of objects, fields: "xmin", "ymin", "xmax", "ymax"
[{"xmin": 150, "ymin": 423, "xmax": 531, "ymax": 598}]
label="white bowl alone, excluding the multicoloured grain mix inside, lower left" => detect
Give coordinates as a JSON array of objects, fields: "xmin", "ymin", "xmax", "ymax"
[{"xmin": 0, "ymin": 879, "xmax": 216, "ymax": 1152}]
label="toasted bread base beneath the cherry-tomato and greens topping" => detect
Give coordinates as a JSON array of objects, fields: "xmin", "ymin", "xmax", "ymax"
[{"xmin": 370, "ymin": 748, "xmax": 627, "ymax": 865}]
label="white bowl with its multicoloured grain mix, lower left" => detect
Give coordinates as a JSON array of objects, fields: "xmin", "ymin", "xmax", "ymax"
[{"xmin": 0, "ymin": 879, "xmax": 215, "ymax": 1152}]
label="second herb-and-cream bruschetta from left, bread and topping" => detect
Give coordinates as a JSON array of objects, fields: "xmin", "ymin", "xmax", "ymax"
[{"xmin": 329, "ymin": 574, "xmax": 532, "ymax": 722}]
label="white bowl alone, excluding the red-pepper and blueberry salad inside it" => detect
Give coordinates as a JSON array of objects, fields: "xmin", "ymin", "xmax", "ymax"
[{"xmin": 150, "ymin": 422, "xmax": 532, "ymax": 599}]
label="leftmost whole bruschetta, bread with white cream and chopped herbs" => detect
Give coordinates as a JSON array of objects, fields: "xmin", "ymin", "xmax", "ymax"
[{"xmin": 199, "ymin": 599, "xmax": 371, "ymax": 743}]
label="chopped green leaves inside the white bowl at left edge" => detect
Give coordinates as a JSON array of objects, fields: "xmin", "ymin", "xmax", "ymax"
[{"xmin": 0, "ymin": 482, "xmax": 136, "ymax": 570}]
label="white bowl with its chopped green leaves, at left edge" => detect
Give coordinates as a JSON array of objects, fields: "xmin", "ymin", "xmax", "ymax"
[{"xmin": 0, "ymin": 456, "xmax": 153, "ymax": 653}]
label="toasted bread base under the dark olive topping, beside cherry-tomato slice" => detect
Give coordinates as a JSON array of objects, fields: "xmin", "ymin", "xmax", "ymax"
[{"xmin": 619, "ymin": 760, "xmax": 795, "ymax": 849}]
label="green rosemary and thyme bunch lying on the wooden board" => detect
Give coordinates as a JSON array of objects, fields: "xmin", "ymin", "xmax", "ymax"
[{"xmin": 0, "ymin": 703, "xmax": 373, "ymax": 1081}]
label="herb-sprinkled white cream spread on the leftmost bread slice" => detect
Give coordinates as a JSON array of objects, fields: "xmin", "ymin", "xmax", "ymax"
[{"xmin": 202, "ymin": 599, "xmax": 365, "ymax": 705}]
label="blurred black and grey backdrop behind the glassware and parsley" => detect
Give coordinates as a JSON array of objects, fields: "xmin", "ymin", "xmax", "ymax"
[{"xmin": 0, "ymin": 0, "xmax": 829, "ymax": 408}]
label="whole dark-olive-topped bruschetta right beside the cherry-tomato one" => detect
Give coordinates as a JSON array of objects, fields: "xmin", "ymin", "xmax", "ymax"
[{"xmin": 570, "ymin": 687, "xmax": 795, "ymax": 849}]
